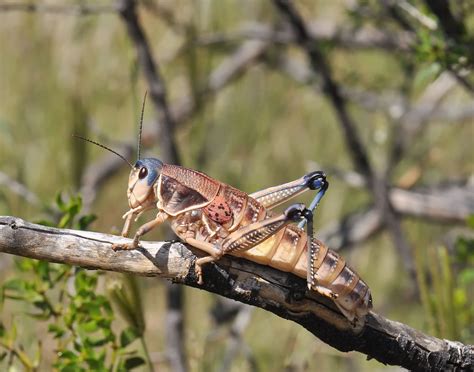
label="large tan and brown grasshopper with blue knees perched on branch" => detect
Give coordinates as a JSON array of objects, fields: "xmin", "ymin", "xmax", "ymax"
[{"xmin": 78, "ymin": 102, "xmax": 372, "ymax": 322}]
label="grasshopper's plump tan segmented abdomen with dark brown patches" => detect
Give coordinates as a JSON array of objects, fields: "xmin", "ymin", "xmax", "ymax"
[{"xmin": 231, "ymin": 225, "xmax": 372, "ymax": 321}]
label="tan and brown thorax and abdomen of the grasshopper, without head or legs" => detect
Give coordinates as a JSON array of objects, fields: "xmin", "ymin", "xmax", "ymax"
[{"xmin": 156, "ymin": 164, "xmax": 371, "ymax": 320}]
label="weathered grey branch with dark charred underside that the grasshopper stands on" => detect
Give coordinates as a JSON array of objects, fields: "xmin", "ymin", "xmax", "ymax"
[{"xmin": 0, "ymin": 216, "xmax": 474, "ymax": 370}]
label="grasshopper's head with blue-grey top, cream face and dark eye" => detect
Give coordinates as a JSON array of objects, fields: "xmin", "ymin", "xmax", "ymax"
[{"xmin": 127, "ymin": 158, "xmax": 163, "ymax": 209}]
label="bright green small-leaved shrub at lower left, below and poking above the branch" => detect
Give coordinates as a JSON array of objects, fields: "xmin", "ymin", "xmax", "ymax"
[{"xmin": 0, "ymin": 195, "xmax": 145, "ymax": 371}]
